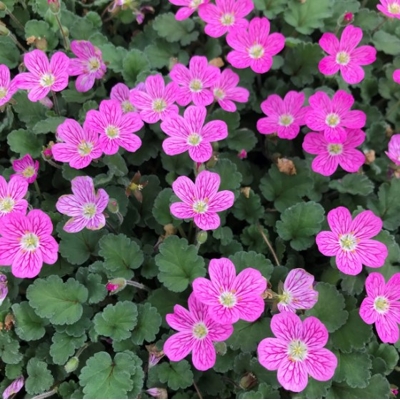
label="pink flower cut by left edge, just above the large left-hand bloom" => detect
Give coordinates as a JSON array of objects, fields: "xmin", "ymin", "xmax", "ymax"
[{"xmin": 0, "ymin": 175, "xmax": 29, "ymax": 218}]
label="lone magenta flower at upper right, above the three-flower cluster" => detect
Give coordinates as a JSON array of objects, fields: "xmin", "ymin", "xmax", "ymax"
[{"xmin": 318, "ymin": 25, "xmax": 376, "ymax": 84}]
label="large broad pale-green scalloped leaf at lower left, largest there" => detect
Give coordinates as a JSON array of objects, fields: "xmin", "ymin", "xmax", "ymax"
[{"xmin": 26, "ymin": 275, "xmax": 88, "ymax": 325}]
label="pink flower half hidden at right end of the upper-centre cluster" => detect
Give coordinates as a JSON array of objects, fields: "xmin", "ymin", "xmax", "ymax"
[{"xmin": 211, "ymin": 68, "xmax": 250, "ymax": 112}]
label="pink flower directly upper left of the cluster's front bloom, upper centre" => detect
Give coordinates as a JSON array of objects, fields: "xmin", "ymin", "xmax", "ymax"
[{"xmin": 129, "ymin": 74, "xmax": 179, "ymax": 124}]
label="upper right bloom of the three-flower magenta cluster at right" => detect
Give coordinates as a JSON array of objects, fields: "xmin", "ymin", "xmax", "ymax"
[{"xmin": 305, "ymin": 90, "xmax": 367, "ymax": 143}]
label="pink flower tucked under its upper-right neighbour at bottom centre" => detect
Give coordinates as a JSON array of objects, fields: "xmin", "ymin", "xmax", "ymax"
[{"xmin": 164, "ymin": 293, "xmax": 233, "ymax": 371}]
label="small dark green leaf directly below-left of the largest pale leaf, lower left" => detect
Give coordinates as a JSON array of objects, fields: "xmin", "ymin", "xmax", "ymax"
[{"xmin": 12, "ymin": 301, "xmax": 46, "ymax": 342}]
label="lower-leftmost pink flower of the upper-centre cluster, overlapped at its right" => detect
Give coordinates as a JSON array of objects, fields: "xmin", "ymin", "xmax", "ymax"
[{"xmin": 51, "ymin": 118, "xmax": 103, "ymax": 169}]
